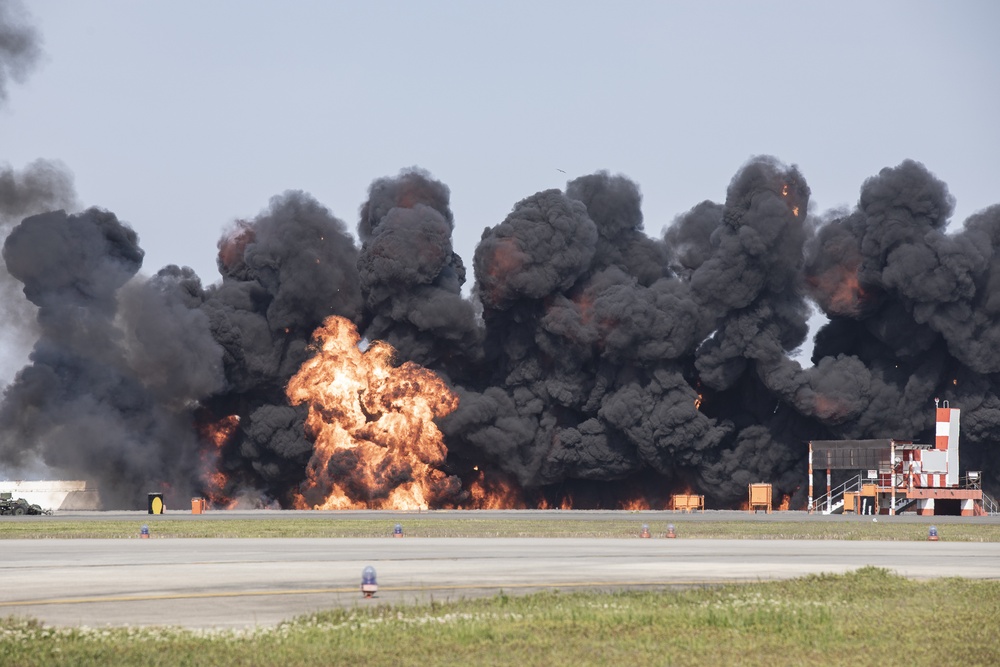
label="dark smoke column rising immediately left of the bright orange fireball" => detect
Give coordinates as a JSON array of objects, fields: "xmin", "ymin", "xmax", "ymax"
[{"xmin": 198, "ymin": 192, "xmax": 361, "ymax": 502}]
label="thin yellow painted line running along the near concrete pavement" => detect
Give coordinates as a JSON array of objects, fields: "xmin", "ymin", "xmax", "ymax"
[{"xmin": 0, "ymin": 578, "xmax": 761, "ymax": 607}]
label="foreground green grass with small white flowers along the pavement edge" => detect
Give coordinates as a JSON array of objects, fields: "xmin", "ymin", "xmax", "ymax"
[{"xmin": 0, "ymin": 568, "xmax": 1000, "ymax": 667}]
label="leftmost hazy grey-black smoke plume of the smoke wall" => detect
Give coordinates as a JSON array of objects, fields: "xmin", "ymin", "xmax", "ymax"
[{"xmin": 0, "ymin": 209, "xmax": 209, "ymax": 506}]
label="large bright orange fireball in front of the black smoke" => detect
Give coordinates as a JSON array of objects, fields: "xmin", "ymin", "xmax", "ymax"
[{"xmin": 287, "ymin": 316, "xmax": 460, "ymax": 509}]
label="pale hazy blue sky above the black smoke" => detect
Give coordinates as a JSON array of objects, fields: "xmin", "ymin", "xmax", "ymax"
[{"xmin": 0, "ymin": 0, "xmax": 1000, "ymax": 298}]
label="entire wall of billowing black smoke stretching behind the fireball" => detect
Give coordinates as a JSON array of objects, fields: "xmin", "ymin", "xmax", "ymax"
[{"xmin": 0, "ymin": 157, "xmax": 1000, "ymax": 507}]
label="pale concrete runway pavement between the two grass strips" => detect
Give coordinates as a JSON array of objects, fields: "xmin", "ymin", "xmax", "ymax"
[{"xmin": 0, "ymin": 537, "xmax": 1000, "ymax": 627}]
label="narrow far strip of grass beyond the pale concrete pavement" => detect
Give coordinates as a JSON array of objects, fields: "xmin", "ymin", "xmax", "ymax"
[{"xmin": 0, "ymin": 515, "xmax": 1000, "ymax": 542}]
